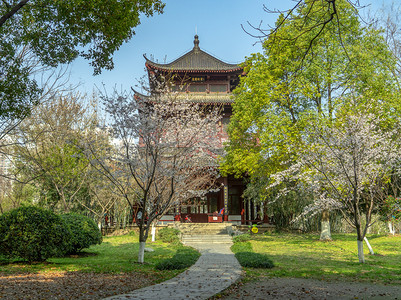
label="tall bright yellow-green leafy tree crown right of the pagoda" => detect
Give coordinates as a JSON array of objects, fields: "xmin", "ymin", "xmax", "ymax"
[{"xmin": 222, "ymin": 0, "xmax": 398, "ymax": 236}]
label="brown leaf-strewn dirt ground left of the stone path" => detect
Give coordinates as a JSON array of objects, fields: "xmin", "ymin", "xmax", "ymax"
[{"xmin": 0, "ymin": 272, "xmax": 156, "ymax": 300}]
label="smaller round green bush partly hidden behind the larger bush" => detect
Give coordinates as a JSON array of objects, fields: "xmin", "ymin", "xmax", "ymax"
[{"xmin": 61, "ymin": 213, "xmax": 102, "ymax": 254}]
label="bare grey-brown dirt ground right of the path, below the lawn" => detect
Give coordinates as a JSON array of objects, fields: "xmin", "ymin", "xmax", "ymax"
[{"xmin": 215, "ymin": 278, "xmax": 401, "ymax": 300}]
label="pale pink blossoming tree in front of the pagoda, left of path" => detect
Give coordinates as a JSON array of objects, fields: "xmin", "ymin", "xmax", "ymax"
[{"xmin": 89, "ymin": 84, "xmax": 220, "ymax": 263}]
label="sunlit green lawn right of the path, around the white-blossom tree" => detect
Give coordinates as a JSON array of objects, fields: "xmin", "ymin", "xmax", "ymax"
[{"xmin": 232, "ymin": 233, "xmax": 401, "ymax": 284}]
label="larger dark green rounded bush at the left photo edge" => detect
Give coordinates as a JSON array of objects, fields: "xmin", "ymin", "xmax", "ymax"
[{"xmin": 0, "ymin": 206, "xmax": 71, "ymax": 261}]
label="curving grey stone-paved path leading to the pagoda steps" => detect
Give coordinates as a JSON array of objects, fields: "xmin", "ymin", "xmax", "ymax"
[{"xmin": 106, "ymin": 243, "xmax": 241, "ymax": 300}]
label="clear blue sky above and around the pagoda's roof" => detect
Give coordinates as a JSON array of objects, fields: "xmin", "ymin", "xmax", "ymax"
[{"xmin": 70, "ymin": 0, "xmax": 391, "ymax": 93}]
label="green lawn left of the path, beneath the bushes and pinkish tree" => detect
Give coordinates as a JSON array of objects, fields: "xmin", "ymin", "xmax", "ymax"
[{"xmin": 0, "ymin": 234, "xmax": 197, "ymax": 281}]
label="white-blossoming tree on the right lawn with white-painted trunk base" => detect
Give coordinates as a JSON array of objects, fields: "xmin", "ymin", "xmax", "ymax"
[{"xmin": 270, "ymin": 103, "xmax": 400, "ymax": 262}]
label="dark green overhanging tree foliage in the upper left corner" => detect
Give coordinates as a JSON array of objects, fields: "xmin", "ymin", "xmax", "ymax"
[{"xmin": 0, "ymin": 0, "xmax": 164, "ymax": 117}]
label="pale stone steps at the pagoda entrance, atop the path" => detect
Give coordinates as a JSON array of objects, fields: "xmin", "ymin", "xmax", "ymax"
[{"xmin": 175, "ymin": 223, "xmax": 232, "ymax": 244}]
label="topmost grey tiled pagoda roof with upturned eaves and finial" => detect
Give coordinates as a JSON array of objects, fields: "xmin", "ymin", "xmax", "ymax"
[{"xmin": 144, "ymin": 35, "xmax": 243, "ymax": 73}]
